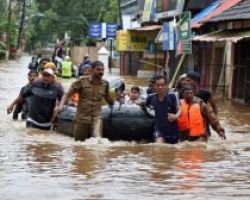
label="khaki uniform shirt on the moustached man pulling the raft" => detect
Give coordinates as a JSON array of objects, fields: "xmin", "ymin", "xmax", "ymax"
[{"xmin": 70, "ymin": 76, "xmax": 109, "ymax": 123}]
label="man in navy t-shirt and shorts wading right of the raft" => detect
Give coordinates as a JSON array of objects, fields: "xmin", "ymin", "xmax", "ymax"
[{"xmin": 146, "ymin": 76, "xmax": 181, "ymax": 144}]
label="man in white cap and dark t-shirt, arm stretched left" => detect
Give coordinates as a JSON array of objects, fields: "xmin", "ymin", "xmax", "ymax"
[{"xmin": 7, "ymin": 68, "xmax": 64, "ymax": 130}]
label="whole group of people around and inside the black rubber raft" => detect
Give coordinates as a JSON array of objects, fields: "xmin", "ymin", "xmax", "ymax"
[{"xmin": 7, "ymin": 53, "xmax": 226, "ymax": 144}]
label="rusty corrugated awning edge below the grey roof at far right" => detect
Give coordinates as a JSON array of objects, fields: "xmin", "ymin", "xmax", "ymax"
[{"xmin": 192, "ymin": 30, "xmax": 250, "ymax": 43}]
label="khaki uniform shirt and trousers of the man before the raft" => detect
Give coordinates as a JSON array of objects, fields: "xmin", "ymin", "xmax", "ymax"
[{"xmin": 70, "ymin": 76, "xmax": 109, "ymax": 141}]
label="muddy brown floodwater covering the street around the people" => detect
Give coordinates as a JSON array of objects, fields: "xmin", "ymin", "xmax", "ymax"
[{"xmin": 0, "ymin": 56, "xmax": 250, "ymax": 200}]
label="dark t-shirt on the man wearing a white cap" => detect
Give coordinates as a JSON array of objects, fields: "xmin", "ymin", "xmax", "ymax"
[{"xmin": 21, "ymin": 79, "xmax": 64, "ymax": 123}]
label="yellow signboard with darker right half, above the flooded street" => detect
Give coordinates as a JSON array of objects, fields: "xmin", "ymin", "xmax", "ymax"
[{"xmin": 117, "ymin": 31, "xmax": 148, "ymax": 51}]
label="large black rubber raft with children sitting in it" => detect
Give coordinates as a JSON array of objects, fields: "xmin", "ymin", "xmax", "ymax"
[{"xmin": 56, "ymin": 105, "xmax": 154, "ymax": 141}]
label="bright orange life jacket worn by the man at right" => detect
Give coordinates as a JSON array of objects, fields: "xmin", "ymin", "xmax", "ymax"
[{"xmin": 177, "ymin": 99, "xmax": 206, "ymax": 137}]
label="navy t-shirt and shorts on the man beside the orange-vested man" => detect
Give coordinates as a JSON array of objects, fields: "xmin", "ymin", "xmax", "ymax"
[{"xmin": 146, "ymin": 93, "xmax": 179, "ymax": 144}]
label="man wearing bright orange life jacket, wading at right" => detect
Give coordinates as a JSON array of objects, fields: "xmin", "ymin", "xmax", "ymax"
[{"xmin": 177, "ymin": 85, "xmax": 226, "ymax": 141}]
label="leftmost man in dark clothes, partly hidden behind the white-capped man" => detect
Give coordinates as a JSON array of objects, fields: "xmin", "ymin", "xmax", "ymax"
[{"xmin": 8, "ymin": 70, "xmax": 38, "ymax": 120}]
